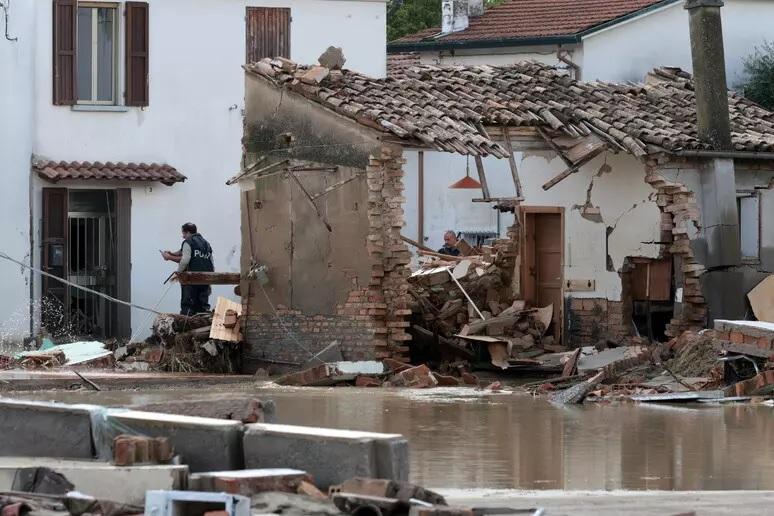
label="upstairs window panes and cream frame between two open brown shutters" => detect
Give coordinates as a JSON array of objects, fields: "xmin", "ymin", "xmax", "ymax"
[{"xmin": 75, "ymin": 3, "xmax": 118, "ymax": 104}]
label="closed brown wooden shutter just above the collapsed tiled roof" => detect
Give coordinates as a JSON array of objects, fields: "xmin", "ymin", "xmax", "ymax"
[{"xmin": 246, "ymin": 7, "xmax": 290, "ymax": 63}]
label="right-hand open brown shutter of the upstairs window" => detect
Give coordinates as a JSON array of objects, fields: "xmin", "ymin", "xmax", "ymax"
[{"xmin": 126, "ymin": 2, "xmax": 149, "ymax": 106}]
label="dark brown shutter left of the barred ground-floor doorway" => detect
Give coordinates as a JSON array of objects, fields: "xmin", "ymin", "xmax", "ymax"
[{"xmin": 41, "ymin": 188, "xmax": 69, "ymax": 332}]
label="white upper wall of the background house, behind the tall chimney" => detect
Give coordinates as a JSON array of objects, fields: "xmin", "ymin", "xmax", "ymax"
[{"xmin": 582, "ymin": 0, "xmax": 774, "ymax": 83}]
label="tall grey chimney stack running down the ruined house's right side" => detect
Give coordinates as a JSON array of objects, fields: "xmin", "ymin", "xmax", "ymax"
[{"xmin": 685, "ymin": 0, "xmax": 745, "ymax": 323}]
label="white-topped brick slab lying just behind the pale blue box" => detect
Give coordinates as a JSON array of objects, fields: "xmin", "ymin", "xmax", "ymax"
[{"xmin": 189, "ymin": 468, "xmax": 311, "ymax": 496}]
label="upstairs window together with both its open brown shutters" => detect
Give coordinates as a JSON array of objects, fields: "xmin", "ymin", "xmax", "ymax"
[{"xmin": 52, "ymin": 0, "xmax": 150, "ymax": 106}]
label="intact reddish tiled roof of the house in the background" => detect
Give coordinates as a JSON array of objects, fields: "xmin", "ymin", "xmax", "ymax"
[{"xmin": 390, "ymin": 0, "xmax": 674, "ymax": 45}]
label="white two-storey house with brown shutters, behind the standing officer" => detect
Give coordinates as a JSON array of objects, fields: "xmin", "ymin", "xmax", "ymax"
[{"xmin": 0, "ymin": 0, "xmax": 385, "ymax": 346}]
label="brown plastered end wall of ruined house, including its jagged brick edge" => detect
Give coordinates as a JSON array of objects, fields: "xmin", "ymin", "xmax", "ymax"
[{"xmin": 240, "ymin": 76, "xmax": 408, "ymax": 372}]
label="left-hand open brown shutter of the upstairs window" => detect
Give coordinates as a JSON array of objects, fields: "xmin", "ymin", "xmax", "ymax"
[{"xmin": 52, "ymin": 0, "xmax": 78, "ymax": 106}]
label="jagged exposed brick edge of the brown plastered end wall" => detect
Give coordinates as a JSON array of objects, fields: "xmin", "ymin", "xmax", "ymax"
[{"xmin": 366, "ymin": 144, "xmax": 411, "ymax": 360}]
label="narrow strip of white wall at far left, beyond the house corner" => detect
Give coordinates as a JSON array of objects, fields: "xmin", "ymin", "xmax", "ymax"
[{"xmin": 0, "ymin": 0, "xmax": 34, "ymax": 346}]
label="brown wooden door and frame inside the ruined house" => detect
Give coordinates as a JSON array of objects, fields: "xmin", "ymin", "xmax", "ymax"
[{"xmin": 521, "ymin": 206, "xmax": 564, "ymax": 342}]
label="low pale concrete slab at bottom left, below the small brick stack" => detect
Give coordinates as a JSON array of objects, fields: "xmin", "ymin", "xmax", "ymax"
[{"xmin": 0, "ymin": 457, "xmax": 188, "ymax": 505}]
